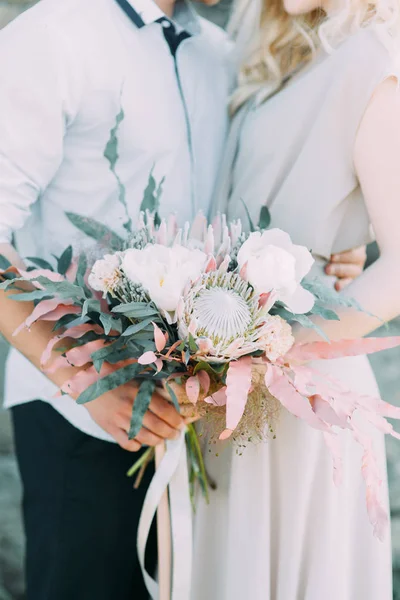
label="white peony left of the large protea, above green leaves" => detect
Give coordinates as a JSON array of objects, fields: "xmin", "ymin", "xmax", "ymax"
[{"xmin": 121, "ymin": 244, "xmax": 207, "ymax": 313}]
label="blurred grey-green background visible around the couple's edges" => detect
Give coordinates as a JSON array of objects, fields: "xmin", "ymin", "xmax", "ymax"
[{"xmin": 0, "ymin": 0, "xmax": 400, "ymax": 600}]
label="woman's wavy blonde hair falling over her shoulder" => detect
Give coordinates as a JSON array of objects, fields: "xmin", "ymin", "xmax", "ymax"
[{"xmin": 229, "ymin": 0, "xmax": 400, "ymax": 113}]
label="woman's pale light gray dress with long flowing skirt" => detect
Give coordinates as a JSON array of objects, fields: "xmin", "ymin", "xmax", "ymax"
[{"xmin": 192, "ymin": 31, "xmax": 395, "ymax": 600}]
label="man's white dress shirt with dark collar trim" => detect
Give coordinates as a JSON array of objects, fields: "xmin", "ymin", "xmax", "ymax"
[{"xmin": 0, "ymin": 0, "xmax": 230, "ymax": 440}]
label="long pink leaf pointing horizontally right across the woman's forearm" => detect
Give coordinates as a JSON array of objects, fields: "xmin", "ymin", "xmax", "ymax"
[{"xmin": 286, "ymin": 336, "xmax": 400, "ymax": 361}]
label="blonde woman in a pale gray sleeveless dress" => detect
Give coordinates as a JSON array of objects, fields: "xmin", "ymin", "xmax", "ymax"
[{"xmin": 192, "ymin": 0, "xmax": 400, "ymax": 600}]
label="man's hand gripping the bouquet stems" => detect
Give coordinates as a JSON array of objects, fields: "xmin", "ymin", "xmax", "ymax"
[{"xmin": 85, "ymin": 383, "xmax": 185, "ymax": 452}]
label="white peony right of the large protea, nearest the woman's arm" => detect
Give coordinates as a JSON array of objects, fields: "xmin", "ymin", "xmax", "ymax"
[{"xmin": 237, "ymin": 229, "xmax": 314, "ymax": 314}]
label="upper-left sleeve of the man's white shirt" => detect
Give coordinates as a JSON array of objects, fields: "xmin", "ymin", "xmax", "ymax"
[{"xmin": 0, "ymin": 15, "xmax": 82, "ymax": 243}]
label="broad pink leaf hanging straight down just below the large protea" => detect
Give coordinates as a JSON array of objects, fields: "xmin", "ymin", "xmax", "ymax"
[{"xmin": 226, "ymin": 356, "xmax": 252, "ymax": 431}]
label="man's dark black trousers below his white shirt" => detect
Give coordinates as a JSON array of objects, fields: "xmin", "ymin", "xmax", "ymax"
[{"xmin": 12, "ymin": 401, "xmax": 156, "ymax": 600}]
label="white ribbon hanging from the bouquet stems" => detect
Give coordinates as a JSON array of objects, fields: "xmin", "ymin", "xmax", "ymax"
[{"xmin": 137, "ymin": 432, "xmax": 193, "ymax": 600}]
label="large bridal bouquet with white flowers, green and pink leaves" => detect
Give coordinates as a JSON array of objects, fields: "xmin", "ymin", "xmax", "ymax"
[{"xmin": 0, "ymin": 185, "xmax": 400, "ymax": 537}]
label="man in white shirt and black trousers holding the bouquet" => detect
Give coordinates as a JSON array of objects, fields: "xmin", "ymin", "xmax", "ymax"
[{"xmin": 0, "ymin": 0, "xmax": 368, "ymax": 600}]
